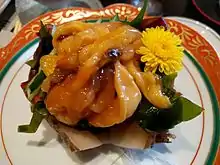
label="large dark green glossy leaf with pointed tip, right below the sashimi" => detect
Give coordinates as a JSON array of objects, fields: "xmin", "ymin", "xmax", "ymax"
[{"xmin": 134, "ymin": 97, "xmax": 202, "ymax": 132}]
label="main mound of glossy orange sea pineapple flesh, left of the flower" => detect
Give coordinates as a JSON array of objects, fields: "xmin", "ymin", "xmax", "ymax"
[{"xmin": 45, "ymin": 22, "xmax": 170, "ymax": 127}]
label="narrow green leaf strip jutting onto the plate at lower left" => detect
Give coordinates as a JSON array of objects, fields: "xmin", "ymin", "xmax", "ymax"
[{"xmin": 18, "ymin": 102, "xmax": 48, "ymax": 133}]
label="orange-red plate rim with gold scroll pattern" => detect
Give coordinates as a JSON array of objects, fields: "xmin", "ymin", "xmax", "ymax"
[{"xmin": 0, "ymin": 4, "xmax": 220, "ymax": 164}]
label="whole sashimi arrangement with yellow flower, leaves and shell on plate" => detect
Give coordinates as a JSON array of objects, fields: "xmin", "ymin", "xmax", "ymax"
[{"xmin": 18, "ymin": 1, "xmax": 203, "ymax": 150}]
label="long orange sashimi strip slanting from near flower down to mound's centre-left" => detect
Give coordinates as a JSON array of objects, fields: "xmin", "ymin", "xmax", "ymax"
[{"xmin": 69, "ymin": 25, "xmax": 140, "ymax": 93}]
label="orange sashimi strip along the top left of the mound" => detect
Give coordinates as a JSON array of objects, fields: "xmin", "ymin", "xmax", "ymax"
[{"xmin": 57, "ymin": 23, "xmax": 121, "ymax": 70}]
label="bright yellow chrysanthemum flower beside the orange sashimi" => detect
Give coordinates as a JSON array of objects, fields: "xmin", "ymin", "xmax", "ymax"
[{"xmin": 136, "ymin": 27, "xmax": 184, "ymax": 75}]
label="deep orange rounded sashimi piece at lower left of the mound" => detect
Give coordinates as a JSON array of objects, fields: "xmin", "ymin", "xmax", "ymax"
[{"xmin": 45, "ymin": 76, "xmax": 95, "ymax": 125}]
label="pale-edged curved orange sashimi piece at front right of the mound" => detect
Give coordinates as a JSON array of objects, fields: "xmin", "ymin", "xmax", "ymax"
[{"xmin": 88, "ymin": 61, "xmax": 141, "ymax": 127}]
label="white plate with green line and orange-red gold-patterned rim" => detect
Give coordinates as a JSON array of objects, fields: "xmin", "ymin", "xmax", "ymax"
[{"xmin": 0, "ymin": 4, "xmax": 220, "ymax": 165}]
